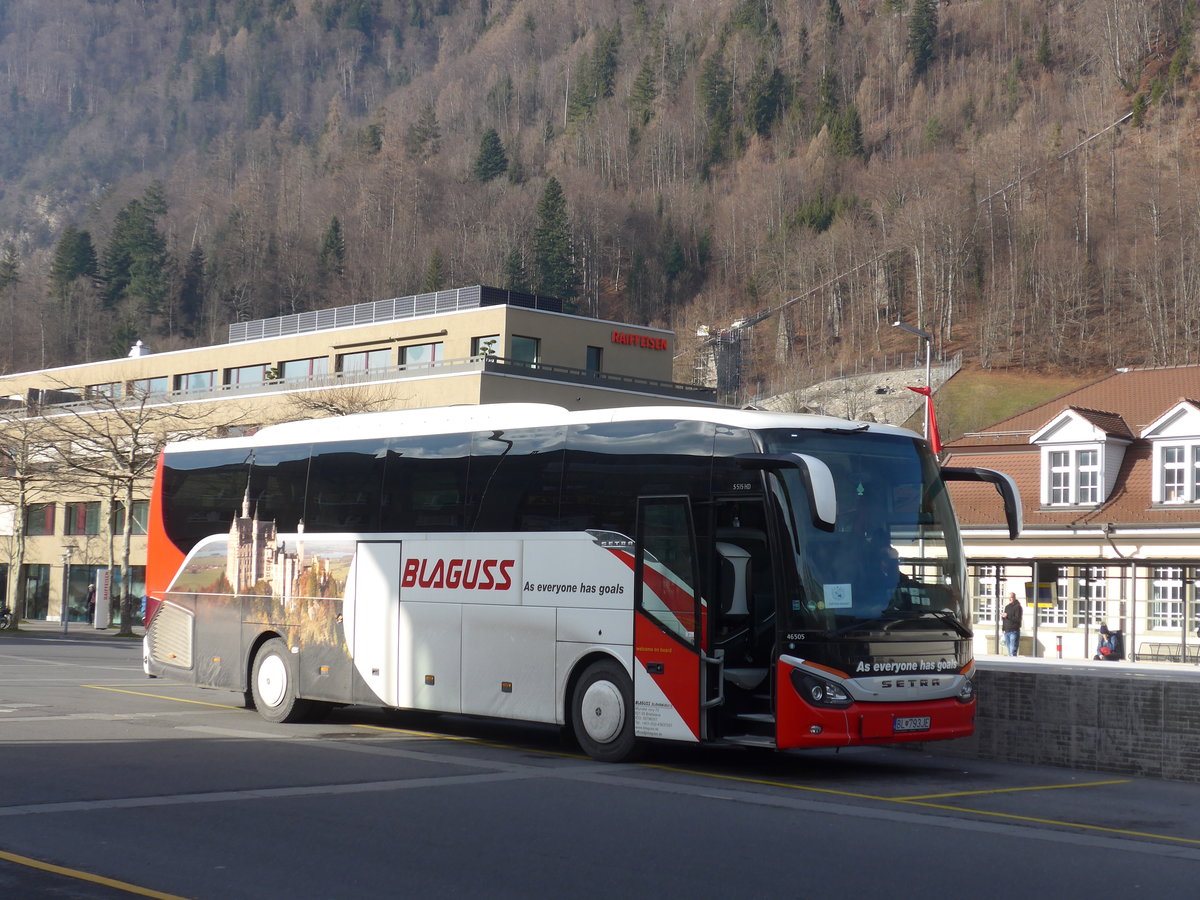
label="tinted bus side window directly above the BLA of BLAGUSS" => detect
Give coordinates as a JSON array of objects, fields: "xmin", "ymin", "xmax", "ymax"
[{"xmin": 380, "ymin": 434, "xmax": 470, "ymax": 532}]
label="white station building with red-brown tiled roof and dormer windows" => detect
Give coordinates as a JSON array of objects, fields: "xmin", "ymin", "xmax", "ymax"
[{"xmin": 946, "ymin": 366, "xmax": 1200, "ymax": 662}]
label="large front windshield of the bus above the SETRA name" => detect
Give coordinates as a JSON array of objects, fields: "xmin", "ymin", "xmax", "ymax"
[{"xmin": 762, "ymin": 430, "xmax": 970, "ymax": 637}]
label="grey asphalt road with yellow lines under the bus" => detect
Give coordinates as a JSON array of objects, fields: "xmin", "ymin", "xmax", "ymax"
[{"xmin": 0, "ymin": 631, "xmax": 1200, "ymax": 900}]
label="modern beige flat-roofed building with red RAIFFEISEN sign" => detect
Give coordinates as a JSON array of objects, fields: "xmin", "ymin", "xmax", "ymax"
[{"xmin": 0, "ymin": 286, "xmax": 715, "ymax": 622}]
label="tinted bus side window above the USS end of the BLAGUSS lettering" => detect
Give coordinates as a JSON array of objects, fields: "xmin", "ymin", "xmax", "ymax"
[{"xmin": 468, "ymin": 428, "xmax": 566, "ymax": 532}]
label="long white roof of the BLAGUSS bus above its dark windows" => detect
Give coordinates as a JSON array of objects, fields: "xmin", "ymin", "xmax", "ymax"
[{"xmin": 167, "ymin": 403, "xmax": 917, "ymax": 452}]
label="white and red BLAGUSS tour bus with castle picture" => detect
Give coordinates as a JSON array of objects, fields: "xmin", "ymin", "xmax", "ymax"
[{"xmin": 145, "ymin": 403, "xmax": 1019, "ymax": 761}]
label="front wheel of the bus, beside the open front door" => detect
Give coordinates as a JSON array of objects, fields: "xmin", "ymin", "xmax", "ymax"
[{"xmin": 571, "ymin": 660, "xmax": 638, "ymax": 762}]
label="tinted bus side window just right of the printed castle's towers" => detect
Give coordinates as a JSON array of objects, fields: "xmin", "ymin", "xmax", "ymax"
[{"xmin": 304, "ymin": 440, "xmax": 386, "ymax": 532}]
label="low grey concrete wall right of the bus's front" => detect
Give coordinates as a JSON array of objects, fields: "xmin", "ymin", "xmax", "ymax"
[{"xmin": 922, "ymin": 658, "xmax": 1200, "ymax": 782}]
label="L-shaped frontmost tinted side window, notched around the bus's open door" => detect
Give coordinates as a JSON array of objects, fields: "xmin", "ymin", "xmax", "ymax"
[{"xmin": 562, "ymin": 421, "xmax": 714, "ymax": 536}]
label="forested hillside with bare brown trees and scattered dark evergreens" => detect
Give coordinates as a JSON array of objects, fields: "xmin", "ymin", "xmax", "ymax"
[{"xmin": 0, "ymin": 0, "xmax": 1200, "ymax": 400}]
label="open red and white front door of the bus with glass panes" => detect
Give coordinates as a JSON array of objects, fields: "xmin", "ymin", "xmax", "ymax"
[{"xmin": 634, "ymin": 497, "xmax": 707, "ymax": 742}]
